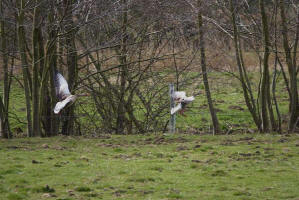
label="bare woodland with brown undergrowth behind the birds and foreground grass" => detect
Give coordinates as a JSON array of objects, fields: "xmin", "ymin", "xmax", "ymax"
[{"xmin": 0, "ymin": 0, "xmax": 299, "ymax": 138}]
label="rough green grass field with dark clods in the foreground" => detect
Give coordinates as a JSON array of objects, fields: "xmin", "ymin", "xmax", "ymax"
[{"xmin": 0, "ymin": 135, "xmax": 299, "ymax": 200}]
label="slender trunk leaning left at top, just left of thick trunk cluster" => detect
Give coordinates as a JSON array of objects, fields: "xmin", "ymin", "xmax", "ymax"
[{"xmin": 17, "ymin": 0, "xmax": 33, "ymax": 137}]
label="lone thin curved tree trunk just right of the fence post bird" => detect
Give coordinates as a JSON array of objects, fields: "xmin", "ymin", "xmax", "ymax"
[{"xmin": 198, "ymin": 0, "xmax": 220, "ymax": 134}]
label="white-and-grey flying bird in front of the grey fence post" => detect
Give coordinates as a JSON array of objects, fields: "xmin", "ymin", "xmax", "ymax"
[{"xmin": 170, "ymin": 91, "xmax": 195, "ymax": 115}]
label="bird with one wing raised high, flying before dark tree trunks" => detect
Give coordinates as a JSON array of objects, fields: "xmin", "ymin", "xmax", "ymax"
[{"xmin": 54, "ymin": 72, "xmax": 77, "ymax": 114}]
